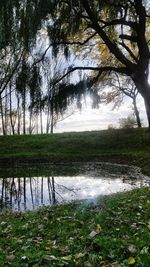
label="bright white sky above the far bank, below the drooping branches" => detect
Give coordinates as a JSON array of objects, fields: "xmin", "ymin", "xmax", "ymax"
[{"xmin": 54, "ymin": 94, "xmax": 147, "ymax": 133}]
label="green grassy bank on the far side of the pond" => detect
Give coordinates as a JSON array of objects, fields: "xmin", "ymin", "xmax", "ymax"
[{"xmin": 0, "ymin": 129, "xmax": 150, "ymax": 174}]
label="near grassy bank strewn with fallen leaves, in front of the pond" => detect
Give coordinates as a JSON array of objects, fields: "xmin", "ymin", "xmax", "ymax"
[{"xmin": 0, "ymin": 188, "xmax": 150, "ymax": 267}]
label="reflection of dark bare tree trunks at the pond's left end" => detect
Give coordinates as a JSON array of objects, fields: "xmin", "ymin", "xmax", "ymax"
[{"xmin": 0, "ymin": 177, "xmax": 62, "ymax": 211}]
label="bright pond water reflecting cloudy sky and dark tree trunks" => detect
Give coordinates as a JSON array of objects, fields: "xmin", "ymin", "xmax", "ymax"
[{"xmin": 0, "ymin": 176, "xmax": 149, "ymax": 211}]
